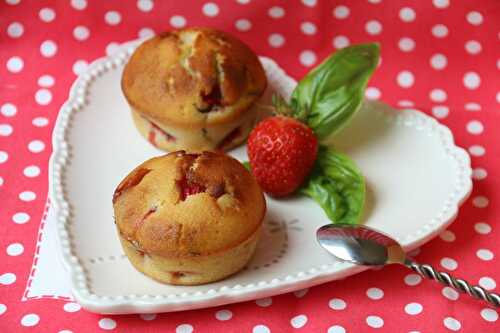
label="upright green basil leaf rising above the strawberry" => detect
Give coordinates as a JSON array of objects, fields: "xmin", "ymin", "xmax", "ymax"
[{"xmin": 290, "ymin": 43, "xmax": 380, "ymax": 140}]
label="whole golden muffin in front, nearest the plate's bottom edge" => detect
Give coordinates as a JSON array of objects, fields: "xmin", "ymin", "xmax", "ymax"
[{"xmin": 113, "ymin": 151, "xmax": 266, "ymax": 285}]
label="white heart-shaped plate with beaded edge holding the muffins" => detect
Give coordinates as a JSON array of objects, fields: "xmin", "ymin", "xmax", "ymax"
[{"xmin": 50, "ymin": 41, "xmax": 472, "ymax": 313}]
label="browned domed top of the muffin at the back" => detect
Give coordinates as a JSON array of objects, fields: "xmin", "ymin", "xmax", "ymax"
[{"xmin": 122, "ymin": 28, "xmax": 267, "ymax": 128}]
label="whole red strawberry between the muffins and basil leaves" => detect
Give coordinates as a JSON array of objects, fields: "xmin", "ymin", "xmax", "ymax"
[{"xmin": 248, "ymin": 116, "xmax": 318, "ymax": 197}]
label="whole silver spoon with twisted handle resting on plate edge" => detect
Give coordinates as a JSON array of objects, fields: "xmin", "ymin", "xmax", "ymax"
[{"xmin": 316, "ymin": 224, "xmax": 500, "ymax": 307}]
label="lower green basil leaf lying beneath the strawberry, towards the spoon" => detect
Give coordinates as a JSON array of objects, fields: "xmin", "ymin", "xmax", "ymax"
[{"xmin": 300, "ymin": 146, "xmax": 366, "ymax": 224}]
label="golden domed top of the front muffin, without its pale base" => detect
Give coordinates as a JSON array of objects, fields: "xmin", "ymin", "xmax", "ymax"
[{"xmin": 113, "ymin": 151, "xmax": 266, "ymax": 257}]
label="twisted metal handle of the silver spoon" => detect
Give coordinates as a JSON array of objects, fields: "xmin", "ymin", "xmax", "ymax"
[{"xmin": 405, "ymin": 260, "xmax": 500, "ymax": 307}]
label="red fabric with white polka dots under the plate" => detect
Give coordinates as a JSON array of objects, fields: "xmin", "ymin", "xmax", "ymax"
[{"xmin": 0, "ymin": 0, "xmax": 500, "ymax": 333}]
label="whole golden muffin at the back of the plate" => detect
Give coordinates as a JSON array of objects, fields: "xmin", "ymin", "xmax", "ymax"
[{"xmin": 121, "ymin": 28, "xmax": 267, "ymax": 151}]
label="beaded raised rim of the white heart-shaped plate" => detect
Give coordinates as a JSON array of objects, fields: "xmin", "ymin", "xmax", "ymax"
[{"xmin": 49, "ymin": 38, "xmax": 472, "ymax": 314}]
